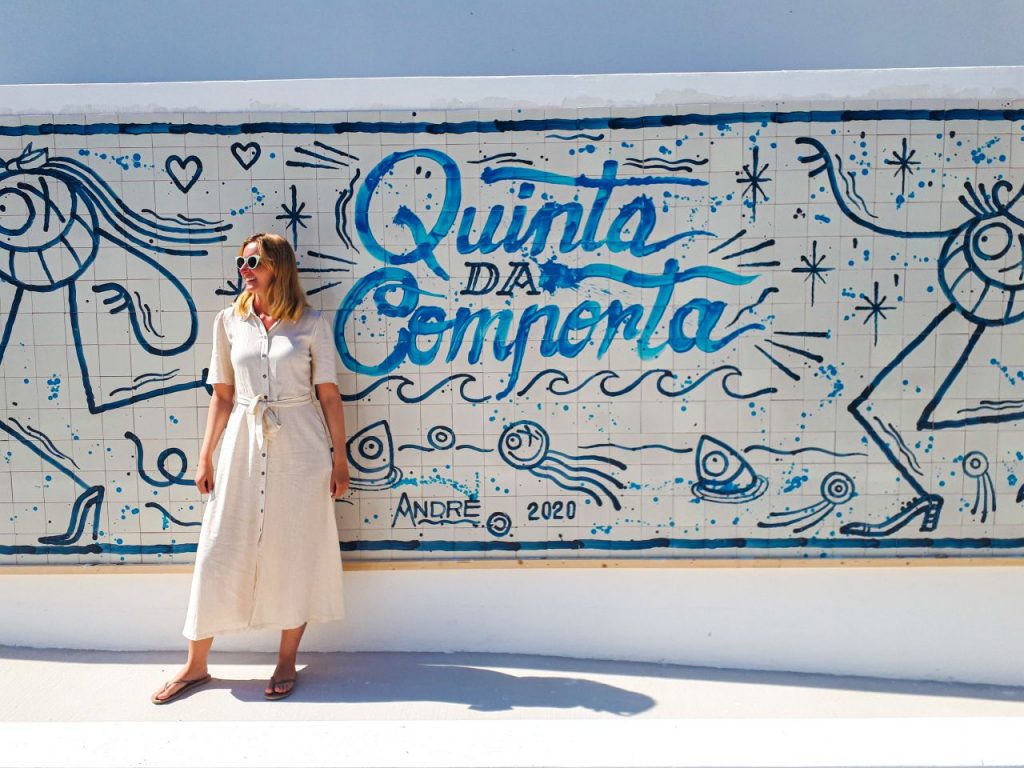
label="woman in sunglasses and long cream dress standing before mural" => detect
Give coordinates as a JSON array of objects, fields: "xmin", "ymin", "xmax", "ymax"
[{"xmin": 151, "ymin": 234, "xmax": 349, "ymax": 705}]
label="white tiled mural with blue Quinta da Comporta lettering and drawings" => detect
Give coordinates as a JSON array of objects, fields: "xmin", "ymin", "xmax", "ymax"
[{"xmin": 0, "ymin": 103, "xmax": 1024, "ymax": 563}]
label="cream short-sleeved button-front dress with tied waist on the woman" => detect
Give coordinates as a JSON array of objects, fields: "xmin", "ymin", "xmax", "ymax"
[{"xmin": 182, "ymin": 306, "xmax": 344, "ymax": 640}]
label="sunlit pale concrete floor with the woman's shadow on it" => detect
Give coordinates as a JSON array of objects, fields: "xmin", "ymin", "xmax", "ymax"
[{"xmin": 0, "ymin": 647, "xmax": 1024, "ymax": 767}]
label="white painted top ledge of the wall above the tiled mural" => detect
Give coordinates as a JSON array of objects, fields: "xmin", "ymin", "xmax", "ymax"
[{"xmin": 0, "ymin": 67, "xmax": 1024, "ymax": 116}]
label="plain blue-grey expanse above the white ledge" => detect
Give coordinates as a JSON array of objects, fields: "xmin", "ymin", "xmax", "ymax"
[{"xmin": 0, "ymin": 0, "xmax": 1024, "ymax": 84}]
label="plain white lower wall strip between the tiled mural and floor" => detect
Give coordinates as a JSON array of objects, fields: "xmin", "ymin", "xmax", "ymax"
[{"xmin": 0, "ymin": 565, "xmax": 1024, "ymax": 685}]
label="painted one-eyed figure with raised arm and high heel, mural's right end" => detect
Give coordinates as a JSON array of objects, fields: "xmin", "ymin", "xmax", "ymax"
[{"xmin": 797, "ymin": 137, "xmax": 1024, "ymax": 537}]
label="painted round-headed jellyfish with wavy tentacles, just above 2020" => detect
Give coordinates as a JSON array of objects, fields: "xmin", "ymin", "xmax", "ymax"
[{"xmin": 498, "ymin": 420, "xmax": 626, "ymax": 510}]
